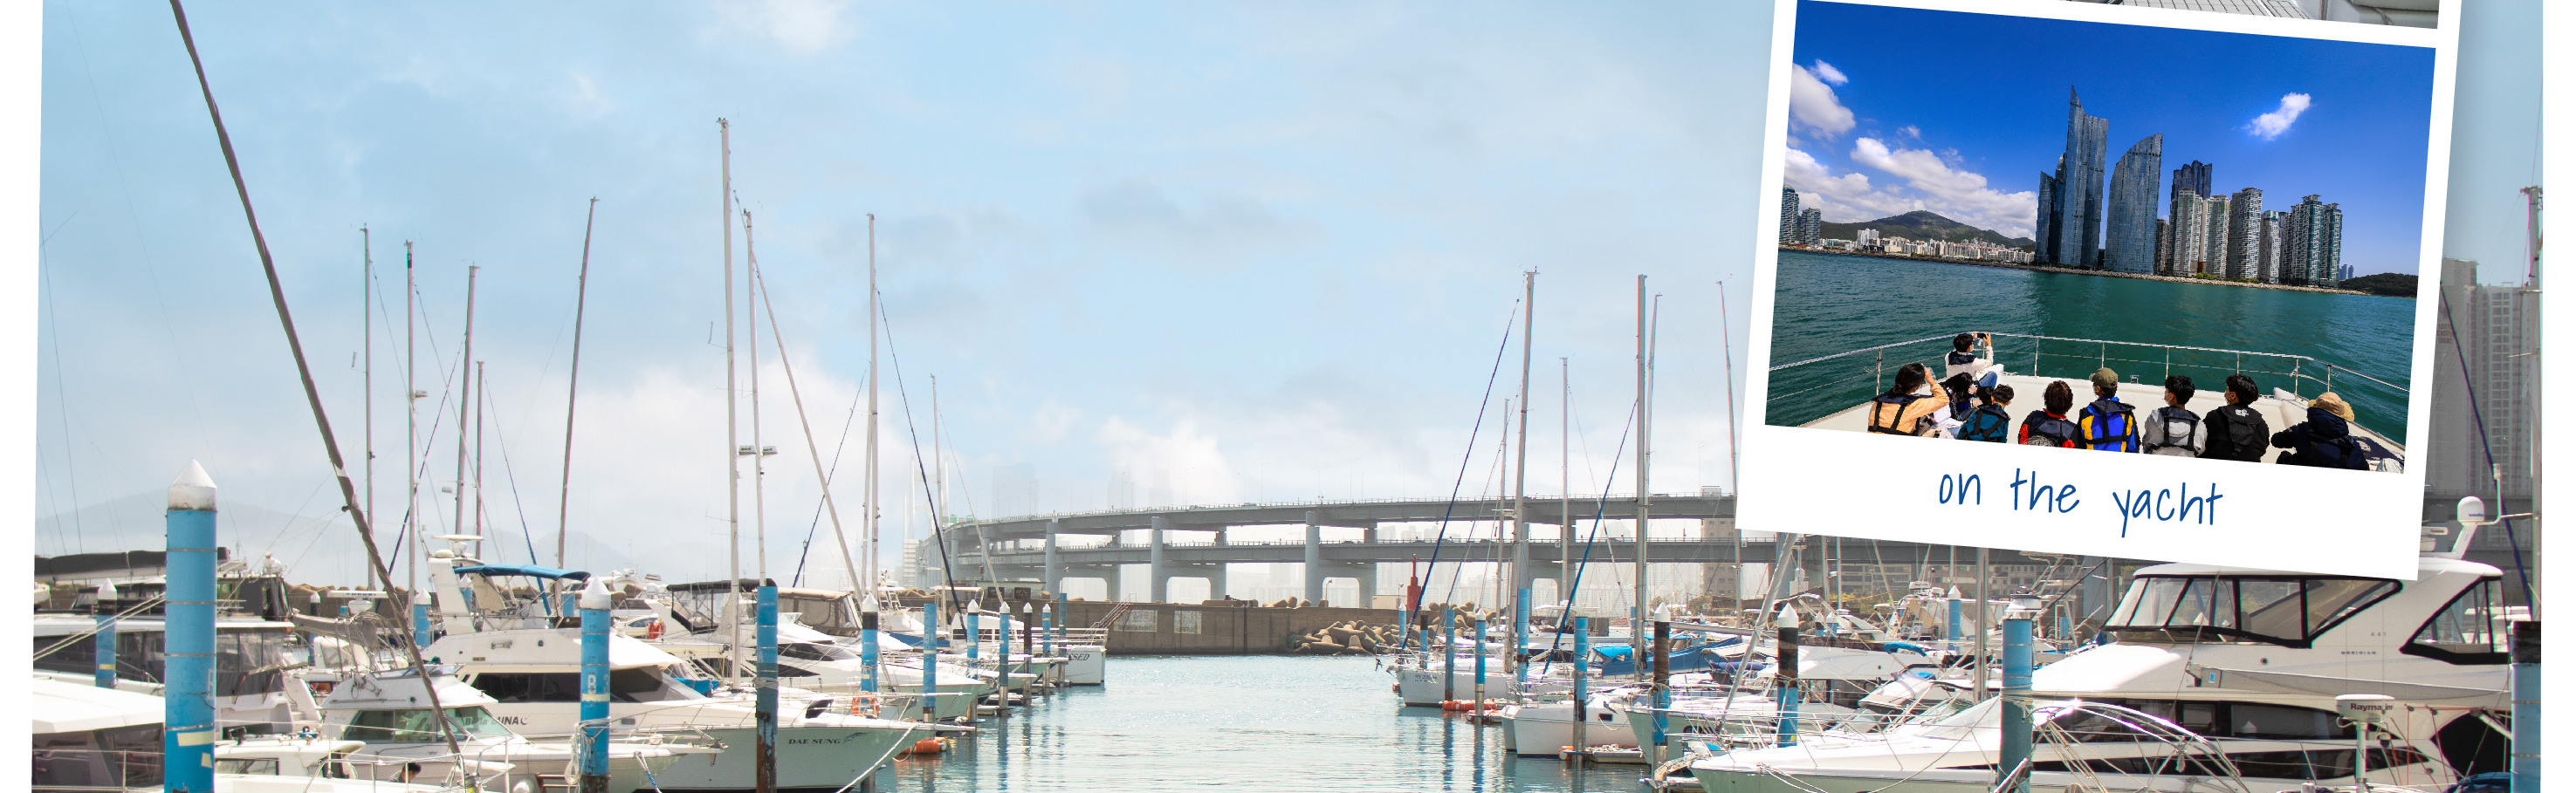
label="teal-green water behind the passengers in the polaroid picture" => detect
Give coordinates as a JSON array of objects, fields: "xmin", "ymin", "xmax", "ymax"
[{"xmin": 1767, "ymin": 250, "xmax": 2416, "ymax": 443}]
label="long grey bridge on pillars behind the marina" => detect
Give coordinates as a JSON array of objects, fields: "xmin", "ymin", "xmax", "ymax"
[{"xmin": 920, "ymin": 495, "xmax": 1775, "ymax": 603}]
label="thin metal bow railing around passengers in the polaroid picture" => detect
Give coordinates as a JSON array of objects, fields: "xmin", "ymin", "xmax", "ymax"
[{"xmin": 1767, "ymin": 332, "xmax": 2408, "ymax": 437}]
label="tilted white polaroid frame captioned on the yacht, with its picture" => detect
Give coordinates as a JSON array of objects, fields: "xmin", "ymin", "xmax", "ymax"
[{"xmin": 1739, "ymin": 0, "xmax": 2457, "ymax": 579}]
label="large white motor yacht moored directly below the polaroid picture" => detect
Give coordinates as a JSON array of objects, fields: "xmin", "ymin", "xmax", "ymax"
[{"xmin": 1687, "ymin": 558, "xmax": 2511, "ymax": 793}]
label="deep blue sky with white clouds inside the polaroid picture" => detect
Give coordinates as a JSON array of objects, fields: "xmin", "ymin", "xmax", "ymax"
[{"xmin": 1788, "ymin": 3, "xmax": 2432, "ymax": 273}]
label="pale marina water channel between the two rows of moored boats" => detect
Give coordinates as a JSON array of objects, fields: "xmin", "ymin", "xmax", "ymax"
[{"xmin": 881, "ymin": 657, "xmax": 1644, "ymax": 793}]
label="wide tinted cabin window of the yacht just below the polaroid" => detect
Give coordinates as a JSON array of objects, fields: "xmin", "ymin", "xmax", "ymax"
[{"xmin": 2107, "ymin": 577, "xmax": 2398, "ymax": 646}]
